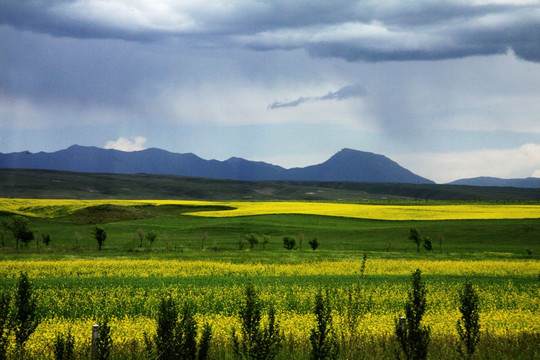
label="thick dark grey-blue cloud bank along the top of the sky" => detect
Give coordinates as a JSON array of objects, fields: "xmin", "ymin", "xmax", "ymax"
[{"xmin": 0, "ymin": 0, "xmax": 540, "ymax": 62}]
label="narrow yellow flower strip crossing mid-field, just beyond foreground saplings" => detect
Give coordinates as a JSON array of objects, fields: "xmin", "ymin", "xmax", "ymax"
[{"xmin": 0, "ymin": 259, "xmax": 540, "ymax": 278}]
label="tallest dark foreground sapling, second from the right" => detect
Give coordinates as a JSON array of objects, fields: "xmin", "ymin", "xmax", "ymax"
[{"xmin": 395, "ymin": 269, "xmax": 431, "ymax": 360}]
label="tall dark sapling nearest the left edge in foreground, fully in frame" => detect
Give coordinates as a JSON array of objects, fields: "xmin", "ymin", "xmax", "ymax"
[{"xmin": 13, "ymin": 273, "xmax": 39, "ymax": 350}]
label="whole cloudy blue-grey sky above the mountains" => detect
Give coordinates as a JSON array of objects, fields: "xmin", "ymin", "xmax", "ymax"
[{"xmin": 0, "ymin": 0, "xmax": 540, "ymax": 183}]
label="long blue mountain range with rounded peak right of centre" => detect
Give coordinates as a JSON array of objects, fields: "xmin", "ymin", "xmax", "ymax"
[{"xmin": 0, "ymin": 145, "xmax": 433, "ymax": 184}]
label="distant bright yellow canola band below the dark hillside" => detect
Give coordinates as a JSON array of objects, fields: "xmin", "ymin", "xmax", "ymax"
[{"xmin": 0, "ymin": 199, "xmax": 540, "ymax": 220}]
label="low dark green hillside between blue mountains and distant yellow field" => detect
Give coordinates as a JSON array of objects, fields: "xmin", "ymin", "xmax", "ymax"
[{"xmin": 0, "ymin": 169, "xmax": 540, "ymax": 202}]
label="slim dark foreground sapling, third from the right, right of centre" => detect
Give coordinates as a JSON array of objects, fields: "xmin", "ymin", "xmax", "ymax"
[{"xmin": 309, "ymin": 291, "xmax": 339, "ymax": 360}]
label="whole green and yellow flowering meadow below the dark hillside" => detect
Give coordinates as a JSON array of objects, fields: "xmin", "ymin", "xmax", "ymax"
[{"xmin": 0, "ymin": 199, "xmax": 540, "ymax": 359}]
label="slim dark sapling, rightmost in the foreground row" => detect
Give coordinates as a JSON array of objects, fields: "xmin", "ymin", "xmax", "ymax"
[{"xmin": 457, "ymin": 280, "xmax": 480, "ymax": 359}]
